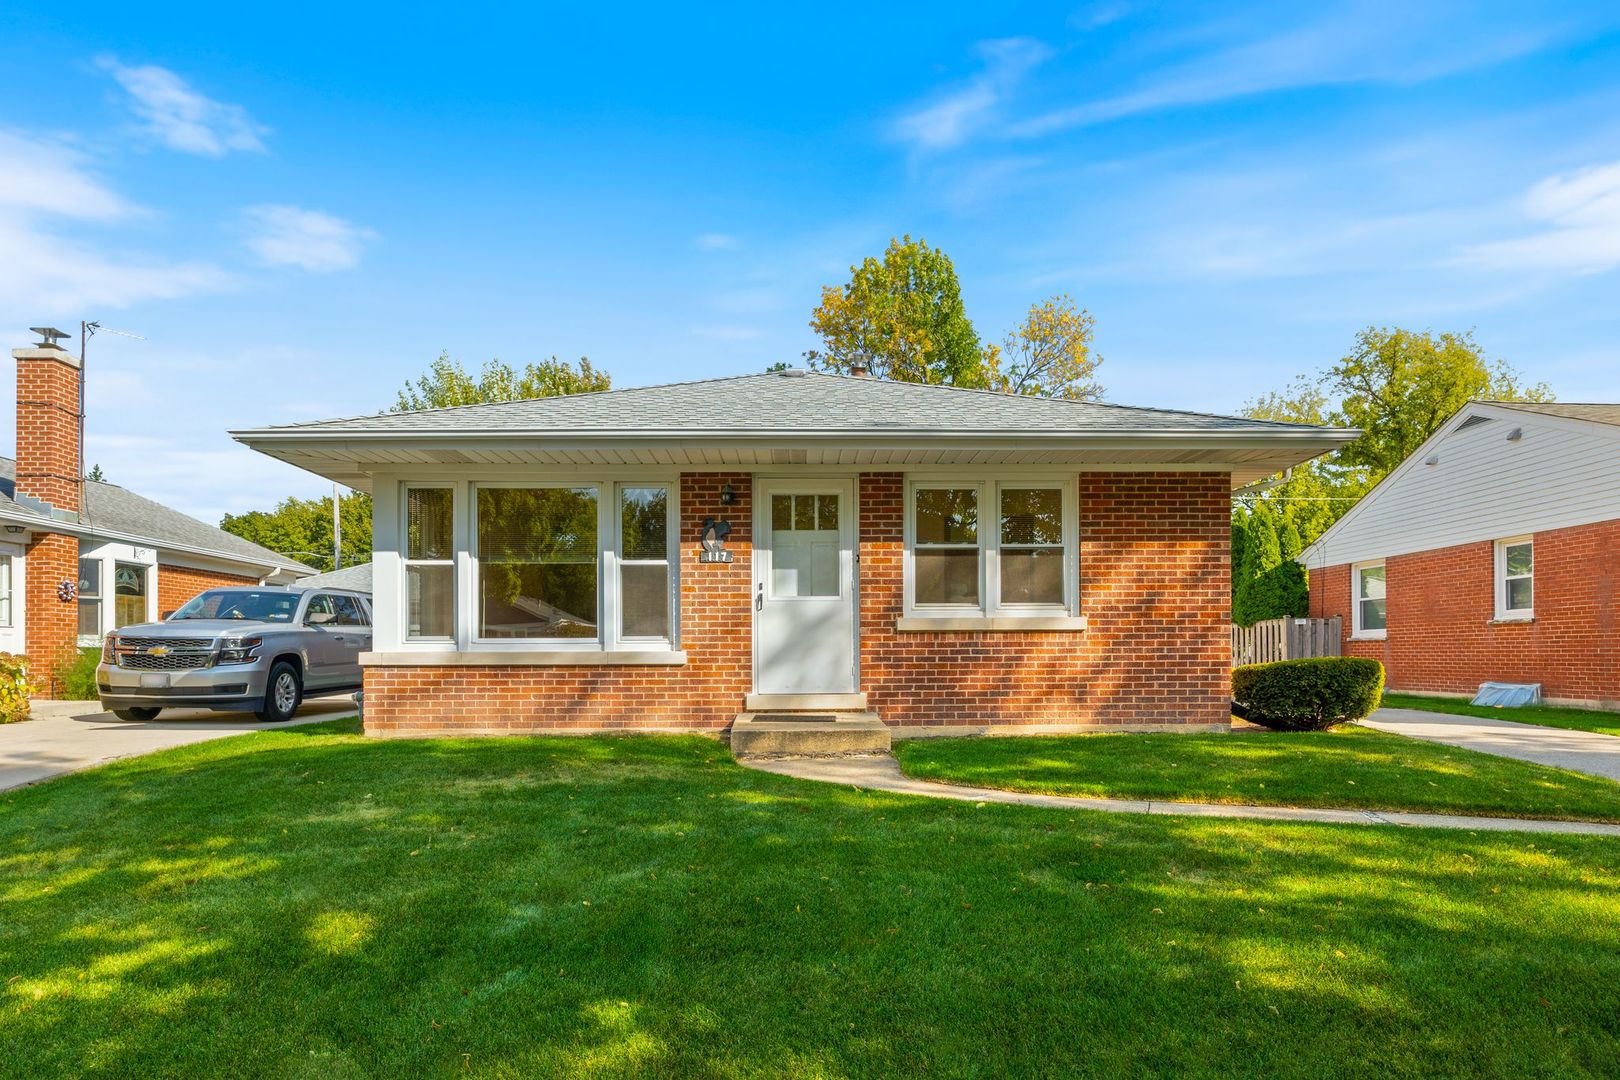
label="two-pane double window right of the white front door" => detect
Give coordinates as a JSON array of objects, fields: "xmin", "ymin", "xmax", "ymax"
[{"xmin": 909, "ymin": 481, "xmax": 1076, "ymax": 615}]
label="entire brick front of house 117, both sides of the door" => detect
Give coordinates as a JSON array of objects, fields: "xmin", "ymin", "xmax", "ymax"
[{"xmin": 365, "ymin": 473, "xmax": 1231, "ymax": 735}]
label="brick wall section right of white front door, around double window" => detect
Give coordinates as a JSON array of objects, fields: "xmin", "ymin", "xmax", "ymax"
[{"xmin": 860, "ymin": 473, "xmax": 1231, "ymax": 727}]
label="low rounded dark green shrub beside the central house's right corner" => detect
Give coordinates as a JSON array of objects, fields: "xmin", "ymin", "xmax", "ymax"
[{"xmin": 1231, "ymin": 656, "xmax": 1383, "ymax": 732}]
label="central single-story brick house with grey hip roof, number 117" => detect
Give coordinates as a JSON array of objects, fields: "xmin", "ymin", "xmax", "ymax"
[{"xmin": 233, "ymin": 371, "xmax": 1354, "ymax": 735}]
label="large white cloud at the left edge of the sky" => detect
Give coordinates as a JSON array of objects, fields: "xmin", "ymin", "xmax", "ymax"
[{"xmin": 0, "ymin": 133, "xmax": 228, "ymax": 321}]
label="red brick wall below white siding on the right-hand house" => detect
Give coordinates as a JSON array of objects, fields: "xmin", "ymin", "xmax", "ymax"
[{"xmin": 1311, "ymin": 521, "xmax": 1620, "ymax": 708}]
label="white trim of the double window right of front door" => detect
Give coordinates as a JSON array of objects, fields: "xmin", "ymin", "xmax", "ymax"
[{"xmin": 897, "ymin": 473, "xmax": 1084, "ymax": 630}]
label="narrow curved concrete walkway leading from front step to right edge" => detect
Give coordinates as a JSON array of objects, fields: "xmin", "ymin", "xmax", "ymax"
[{"xmin": 742, "ymin": 755, "xmax": 1620, "ymax": 837}]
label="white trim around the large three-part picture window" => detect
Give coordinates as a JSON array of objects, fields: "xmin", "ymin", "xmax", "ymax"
[{"xmin": 398, "ymin": 471, "xmax": 680, "ymax": 662}]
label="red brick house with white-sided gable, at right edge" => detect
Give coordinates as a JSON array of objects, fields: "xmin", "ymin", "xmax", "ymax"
[{"xmin": 1299, "ymin": 402, "xmax": 1620, "ymax": 708}]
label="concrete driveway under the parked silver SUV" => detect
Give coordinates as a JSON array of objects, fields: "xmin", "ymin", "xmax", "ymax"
[{"xmin": 0, "ymin": 696, "xmax": 355, "ymax": 790}]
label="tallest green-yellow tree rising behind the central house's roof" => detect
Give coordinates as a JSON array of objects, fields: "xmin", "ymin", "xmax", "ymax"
[{"xmin": 805, "ymin": 236, "xmax": 998, "ymax": 389}]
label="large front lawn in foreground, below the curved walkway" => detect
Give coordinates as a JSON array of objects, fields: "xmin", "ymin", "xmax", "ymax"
[{"xmin": 0, "ymin": 722, "xmax": 1620, "ymax": 1078}]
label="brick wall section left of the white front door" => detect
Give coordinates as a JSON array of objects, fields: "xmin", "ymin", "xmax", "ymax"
[{"xmin": 365, "ymin": 473, "xmax": 753, "ymax": 735}]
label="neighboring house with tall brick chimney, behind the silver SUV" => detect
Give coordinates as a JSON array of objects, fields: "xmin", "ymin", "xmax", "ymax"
[{"xmin": 0, "ymin": 338, "xmax": 314, "ymax": 695}]
